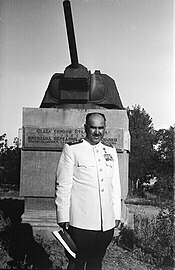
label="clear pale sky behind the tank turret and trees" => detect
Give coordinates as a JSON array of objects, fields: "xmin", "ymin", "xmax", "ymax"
[{"xmin": 0, "ymin": 0, "xmax": 175, "ymax": 144}]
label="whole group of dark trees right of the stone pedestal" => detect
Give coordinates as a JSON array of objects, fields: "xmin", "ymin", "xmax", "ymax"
[{"xmin": 127, "ymin": 105, "xmax": 174, "ymax": 199}]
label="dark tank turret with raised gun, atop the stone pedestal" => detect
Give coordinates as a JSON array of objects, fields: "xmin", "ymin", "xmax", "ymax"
[{"xmin": 40, "ymin": 0, "xmax": 124, "ymax": 109}]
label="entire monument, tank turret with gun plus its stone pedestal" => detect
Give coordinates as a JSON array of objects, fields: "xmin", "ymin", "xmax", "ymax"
[{"xmin": 20, "ymin": 0, "xmax": 130, "ymax": 228}]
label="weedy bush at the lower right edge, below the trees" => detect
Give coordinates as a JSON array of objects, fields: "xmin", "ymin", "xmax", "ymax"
[{"xmin": 115, "ymin": 204, "xmax": 174, "ymax": 266}]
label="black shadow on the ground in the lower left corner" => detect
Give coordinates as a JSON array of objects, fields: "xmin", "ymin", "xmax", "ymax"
[{"xmin": 0, "ymin": 199, "xmax": 52, "ymax": 270}]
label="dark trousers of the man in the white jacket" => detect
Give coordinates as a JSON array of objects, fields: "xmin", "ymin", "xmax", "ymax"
[{"xmin": 66, "ymin": 226, "xmax": 114, "ymax": 270}]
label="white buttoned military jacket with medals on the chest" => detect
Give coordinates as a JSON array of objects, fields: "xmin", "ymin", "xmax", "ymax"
[{"xmin": 55, "ymin": 139, "xmax": 121, "ymax": 231}]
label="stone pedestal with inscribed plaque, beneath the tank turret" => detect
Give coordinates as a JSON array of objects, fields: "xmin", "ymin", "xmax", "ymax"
[{"xmin": 20, "ymin": 106, "xmax": 130, "ymax": 228}]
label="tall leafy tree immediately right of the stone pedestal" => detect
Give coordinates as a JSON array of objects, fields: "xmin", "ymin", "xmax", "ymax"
[{"xmin": 127, "ymin": 105, "xmax": 155, "ymax": 191}]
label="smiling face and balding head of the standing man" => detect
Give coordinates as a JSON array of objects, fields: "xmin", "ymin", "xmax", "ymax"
[{"xmin": 84, "ymin": 114, "xmax": 106, "ymax": 145}]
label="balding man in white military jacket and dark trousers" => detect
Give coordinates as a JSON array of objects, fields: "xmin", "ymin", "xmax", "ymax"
[{"xmin": 55, "ymin": 113, "xmax": 121, "ymax": 270}]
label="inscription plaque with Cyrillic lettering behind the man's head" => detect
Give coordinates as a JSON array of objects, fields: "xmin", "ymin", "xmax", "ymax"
[{"xmin": 23, "ymin": 127, "xmax": 124, "ymax": 151}]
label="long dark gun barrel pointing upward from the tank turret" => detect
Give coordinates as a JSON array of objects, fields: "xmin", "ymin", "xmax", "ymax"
[{"xmin": 63, "ymin": 0, "xmax": 78, "ymax": 68}]
